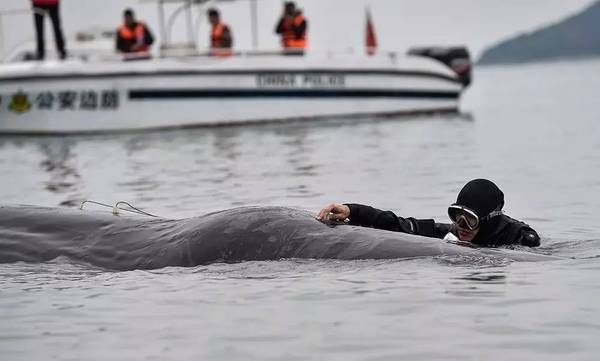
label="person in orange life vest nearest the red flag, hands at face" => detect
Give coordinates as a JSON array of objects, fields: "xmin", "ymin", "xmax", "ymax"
[{"xmin": 275, "ymin": 1, "xmax": 307, "ymax": 55}]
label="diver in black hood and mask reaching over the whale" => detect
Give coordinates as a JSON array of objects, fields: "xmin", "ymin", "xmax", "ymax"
[{"xmin": 317, "ymin": 179, "xmax": 540, "ymax": 247}]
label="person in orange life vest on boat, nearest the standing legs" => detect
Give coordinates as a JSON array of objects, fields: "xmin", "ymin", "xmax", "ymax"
[{"xmin": 116, "ymin": 9, "xmax": 154, "ymax": 56}]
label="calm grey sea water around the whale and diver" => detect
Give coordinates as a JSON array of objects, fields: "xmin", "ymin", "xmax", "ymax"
[{"xmin": 0, "ymin": 61, "xmax": 600, "ymax": 361}]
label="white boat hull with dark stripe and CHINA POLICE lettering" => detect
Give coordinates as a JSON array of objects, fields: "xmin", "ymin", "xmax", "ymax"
[{"xmin": 0, "ymin": 57, "xmax": 463, "ymax": 134}]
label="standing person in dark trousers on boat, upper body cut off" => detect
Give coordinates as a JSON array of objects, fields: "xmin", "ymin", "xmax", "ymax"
[{"xmin": 31, "ymin": 0, "xmax": 67, "ymax": 60}]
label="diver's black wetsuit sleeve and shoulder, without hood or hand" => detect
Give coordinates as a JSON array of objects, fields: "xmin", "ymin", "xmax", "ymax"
[{"xmin": 346, "ymin": 204, "xmax": 540, "ymax": 247}]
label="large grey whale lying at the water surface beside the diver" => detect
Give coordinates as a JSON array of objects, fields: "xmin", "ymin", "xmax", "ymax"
[{"xmin": 0, "ymin": 205, "xmax": 556, "ymax": 271}]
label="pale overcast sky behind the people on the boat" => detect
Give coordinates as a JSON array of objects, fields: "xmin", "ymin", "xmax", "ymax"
[{"xmin": 0, "ymin": 0, "xmax": 595, "ymax": 58}]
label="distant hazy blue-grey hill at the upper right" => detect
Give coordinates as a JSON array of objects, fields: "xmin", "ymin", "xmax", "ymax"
[{"xmin": 478, "ymin": 1, "xmax": 600, "ymax": 64}]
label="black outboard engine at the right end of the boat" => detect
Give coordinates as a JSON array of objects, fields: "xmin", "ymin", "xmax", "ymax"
[{"xmin": 408, "ymin": 46, "xmax": 472, "ymax": 86}]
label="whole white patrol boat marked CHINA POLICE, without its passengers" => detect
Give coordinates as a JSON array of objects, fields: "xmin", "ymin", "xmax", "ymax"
[{"xmin": 0, "ymin": 0, "xmax": 471, "ymax": 134}]
